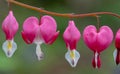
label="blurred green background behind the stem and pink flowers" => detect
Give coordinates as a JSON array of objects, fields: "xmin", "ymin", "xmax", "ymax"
[{"xmin": 0, "ymin": 0, "xmax": 120, "ymax": 74}]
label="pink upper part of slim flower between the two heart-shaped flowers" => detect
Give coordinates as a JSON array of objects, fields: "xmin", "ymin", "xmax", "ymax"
[{"xmin": 63, "ymin": 21, "xmax": 81, "ymax": 50}]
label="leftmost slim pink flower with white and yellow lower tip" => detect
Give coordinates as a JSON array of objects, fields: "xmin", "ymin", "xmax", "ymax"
[{"xmin": 2, "ymin": 11, "xmax": 19, "ymax": 57}]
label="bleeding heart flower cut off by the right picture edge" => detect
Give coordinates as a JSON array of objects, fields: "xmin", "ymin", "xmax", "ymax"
[{"xmin": 113, "ymin": 29, "xmax": 120, "ymax": 65}]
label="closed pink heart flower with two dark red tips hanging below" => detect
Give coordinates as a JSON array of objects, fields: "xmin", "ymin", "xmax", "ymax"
[{"xmin": 83, "ymin": 25, "xmax": 113, "ymax": 68}]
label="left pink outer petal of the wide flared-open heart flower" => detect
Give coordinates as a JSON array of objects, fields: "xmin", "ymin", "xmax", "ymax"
[{"xmin": 21, "ymin": 17, "xmax": 39, "ymax": 44}]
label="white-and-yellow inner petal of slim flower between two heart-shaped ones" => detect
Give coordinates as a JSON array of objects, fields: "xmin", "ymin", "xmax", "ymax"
[{"xmin": 65, "ymin": 49, "xmax": 80, "ymax": 67}]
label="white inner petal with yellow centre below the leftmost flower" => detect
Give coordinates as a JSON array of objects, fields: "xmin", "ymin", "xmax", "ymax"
[{"xmin": 2, "ymin": 40, "xmax": 17, "ymax": 57}]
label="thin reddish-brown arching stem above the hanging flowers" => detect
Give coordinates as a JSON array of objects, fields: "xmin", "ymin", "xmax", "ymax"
[{"xmin": 7, "ymin": 0, "xmax": 120, "ymax": 18}]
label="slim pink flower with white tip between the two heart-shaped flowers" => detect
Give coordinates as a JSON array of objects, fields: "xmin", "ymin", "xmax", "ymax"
[{"xmin": 63, "ymin": 21, "xmax": 81, "ymax": 67}]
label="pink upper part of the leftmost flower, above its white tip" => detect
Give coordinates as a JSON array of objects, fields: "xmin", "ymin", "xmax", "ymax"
[{"xmin": 2, "ymin": 11, "xmax": 19, "ymax": 40}]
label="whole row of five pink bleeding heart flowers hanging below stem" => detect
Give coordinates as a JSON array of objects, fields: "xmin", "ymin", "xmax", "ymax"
[{"xmin": 2, "ymin": 11, "xmax": 120, "ymax": 68}]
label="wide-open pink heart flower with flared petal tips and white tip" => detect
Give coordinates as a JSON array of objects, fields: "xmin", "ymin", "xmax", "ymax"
[{"xmin": 21, "ymin": 15, "xmax": 59, "ymax": 60}]
